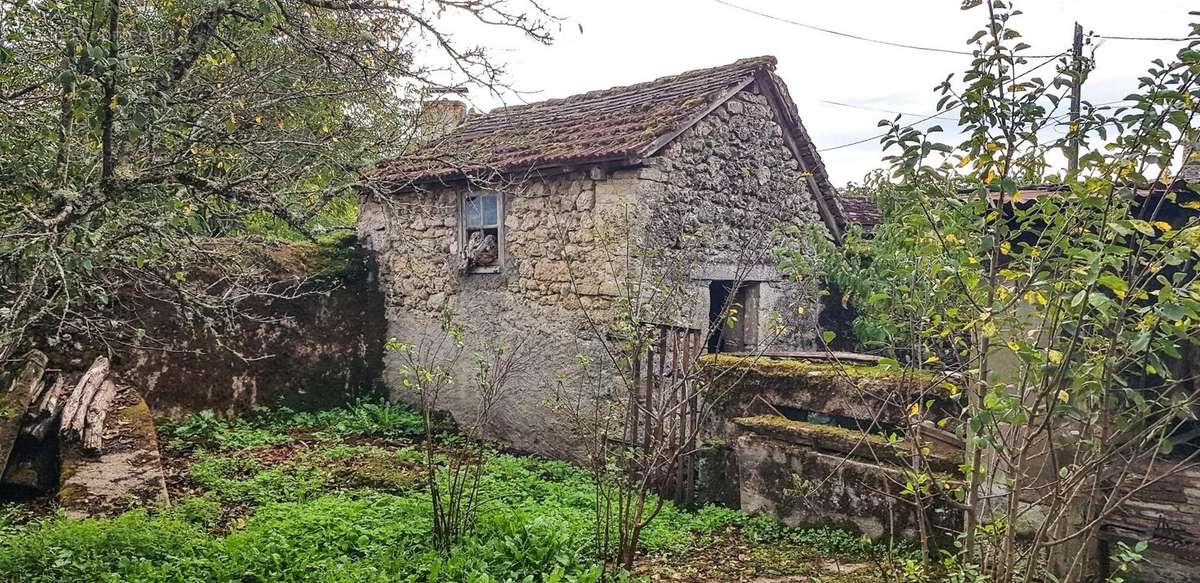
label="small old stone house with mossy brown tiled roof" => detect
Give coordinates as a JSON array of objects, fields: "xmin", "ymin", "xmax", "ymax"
[{"xmin": 359, "ymin": 56, "xmax": 847, "ymax": 455}]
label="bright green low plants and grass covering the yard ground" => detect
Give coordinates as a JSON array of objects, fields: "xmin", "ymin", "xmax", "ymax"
[{"xmin": 0, "ymin": 403, "xmax": 897, "ymax": 583}]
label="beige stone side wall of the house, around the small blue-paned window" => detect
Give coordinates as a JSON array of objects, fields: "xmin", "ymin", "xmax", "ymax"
[{"xmin": 359, "ymin": 169, "xmax": 644, "ymax": 456}]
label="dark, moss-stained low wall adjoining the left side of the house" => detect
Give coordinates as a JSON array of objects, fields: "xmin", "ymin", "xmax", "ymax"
[{"xmin": 100, "ymin": 240, "xmax": 386, "ymax": 419}]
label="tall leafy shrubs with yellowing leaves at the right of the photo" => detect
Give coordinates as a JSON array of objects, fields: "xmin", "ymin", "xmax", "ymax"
[{"xmin": 785, "ymin": 0, "xmax": 1200, "ymax": 583}]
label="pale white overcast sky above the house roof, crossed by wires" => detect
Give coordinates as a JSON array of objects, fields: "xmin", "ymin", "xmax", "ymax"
[{"xmin": 446, "ymin": 0, "xmax": 1200, "ymax": 185}]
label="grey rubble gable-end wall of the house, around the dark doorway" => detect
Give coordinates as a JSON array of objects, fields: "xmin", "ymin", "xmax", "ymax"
[{"xmin": 646, "ymin": 89, "xmax": 823, "ymax": 350}]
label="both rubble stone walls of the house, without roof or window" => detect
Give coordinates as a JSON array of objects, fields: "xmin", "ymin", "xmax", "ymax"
[{"xmin": 359, "ymin": 85, "xmax": 835, "ymax": 455}]
